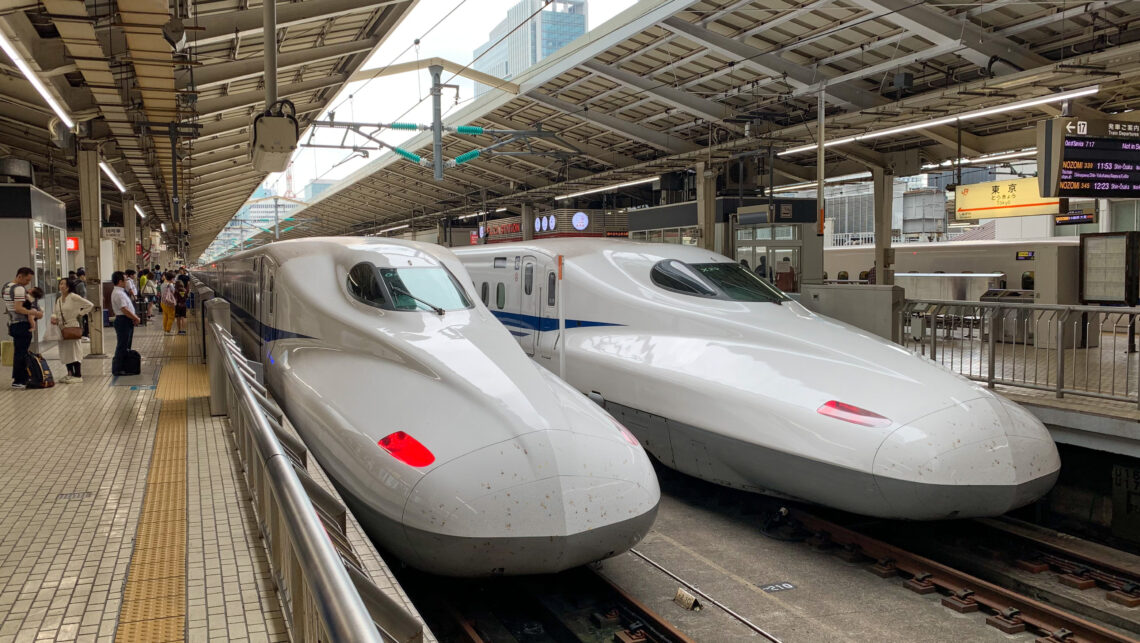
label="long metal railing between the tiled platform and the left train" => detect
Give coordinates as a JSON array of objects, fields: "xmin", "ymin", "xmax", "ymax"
[{"xmin": 202, "ymin": 299, "xmax": 424, "ymax": 643}]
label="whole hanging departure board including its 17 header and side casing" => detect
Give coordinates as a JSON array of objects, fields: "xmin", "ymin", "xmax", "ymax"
[{"xmin": 1037, "ymin": 117, "xmax": 1140, "ymax": 198}]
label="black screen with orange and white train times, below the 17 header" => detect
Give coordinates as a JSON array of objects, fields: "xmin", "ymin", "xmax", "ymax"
[{"xmin": 1057, "ymin": 137, "xmax": 1140, "ymax": 198}]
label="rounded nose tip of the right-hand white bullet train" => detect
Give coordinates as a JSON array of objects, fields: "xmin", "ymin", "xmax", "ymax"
[{"xmin": 874, "ymin": 396, "xmax": 1060, "ymax": 520}]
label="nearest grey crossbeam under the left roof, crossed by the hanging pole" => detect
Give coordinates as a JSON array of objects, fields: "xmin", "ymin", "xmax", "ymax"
[{"xmin": 187, "ymin": 0, "xmax": 409, "ymax": 47}]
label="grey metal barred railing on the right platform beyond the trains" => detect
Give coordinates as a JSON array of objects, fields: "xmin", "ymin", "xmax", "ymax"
[{"xmin": 898, "ymin": 300, "xmax": 1140, "ymax": 406}]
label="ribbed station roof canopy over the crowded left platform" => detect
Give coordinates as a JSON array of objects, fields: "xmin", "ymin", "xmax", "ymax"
[{"xmin": 0, "ymin": 0, "xmax": 417, "ymax": 246}]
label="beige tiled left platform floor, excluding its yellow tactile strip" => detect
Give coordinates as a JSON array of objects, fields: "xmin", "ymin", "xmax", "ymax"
[{"xmin": 0, "ymin": 314, "xmax": 288, "ymax": 643}]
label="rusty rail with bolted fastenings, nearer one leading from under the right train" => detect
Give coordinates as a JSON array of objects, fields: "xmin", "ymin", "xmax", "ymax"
[{"xmin": 789, "ymin": 508, "xmax": 1135, "ymax": 643}]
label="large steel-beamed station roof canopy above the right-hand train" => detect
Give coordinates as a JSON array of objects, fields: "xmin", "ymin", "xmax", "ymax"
[{"xmin": 247, "ymin": 0, "xmax": 1140, "ymax": 256}]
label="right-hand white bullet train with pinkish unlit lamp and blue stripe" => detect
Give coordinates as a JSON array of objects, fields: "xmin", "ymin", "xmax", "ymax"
[{"xmin": 456, "ymin": 239, "xmax": 1060, "ymax": 520}]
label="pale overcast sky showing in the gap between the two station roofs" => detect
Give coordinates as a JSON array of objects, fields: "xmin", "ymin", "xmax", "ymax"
[{"xmin": 267, "ymin": 0, "xmax": 635, "ymax": 197}]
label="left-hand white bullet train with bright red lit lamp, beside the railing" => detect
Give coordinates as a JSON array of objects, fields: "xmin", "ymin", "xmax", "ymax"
[{"xmin": 200, "ymin": 237, "xmax": 660, "ymax": 576}]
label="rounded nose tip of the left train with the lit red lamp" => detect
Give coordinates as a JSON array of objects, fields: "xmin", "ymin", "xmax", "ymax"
[{"xmin": 404, "ymin": 431, "xmax": 660, "ymax": 576}]
